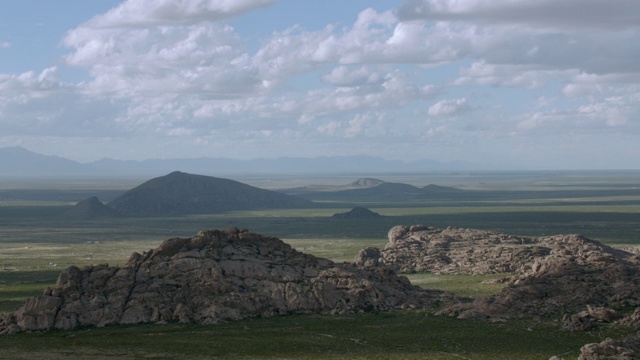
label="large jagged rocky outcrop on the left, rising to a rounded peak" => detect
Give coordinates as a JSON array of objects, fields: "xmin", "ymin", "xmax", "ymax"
[{"xmin": 0, "ymin": 228, "xmax": 457, "ymax": 333}]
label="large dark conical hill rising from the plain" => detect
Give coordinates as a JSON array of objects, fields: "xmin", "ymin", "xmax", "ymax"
[{"xmin": 108, "ymin": 171, "xmax": 313, "ymax": 216}]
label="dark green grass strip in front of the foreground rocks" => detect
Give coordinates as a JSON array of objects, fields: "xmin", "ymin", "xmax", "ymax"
[{"xmin": 0, "ymin": 312, "xmax": 624, "ymax": 360}]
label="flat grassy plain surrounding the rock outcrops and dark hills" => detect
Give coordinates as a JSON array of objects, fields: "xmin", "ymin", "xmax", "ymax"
[{"xmin": 0, "ymin": 172, "xmax": 640, "ymax": 359}]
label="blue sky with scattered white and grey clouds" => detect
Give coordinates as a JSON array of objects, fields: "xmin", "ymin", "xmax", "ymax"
[{"xmin": 0, "ymin": 0, "xmax": 640, "ymax": 169}]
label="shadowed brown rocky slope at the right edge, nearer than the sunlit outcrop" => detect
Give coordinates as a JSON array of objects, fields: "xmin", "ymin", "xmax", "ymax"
[{"xmin": 442, "ymin": 235, "xmax": 640, "ymax": 318}]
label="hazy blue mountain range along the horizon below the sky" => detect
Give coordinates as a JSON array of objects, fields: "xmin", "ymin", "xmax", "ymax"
[{"xmin": 0, "ymin": 147, "xmax": 483, "ymax": 177}]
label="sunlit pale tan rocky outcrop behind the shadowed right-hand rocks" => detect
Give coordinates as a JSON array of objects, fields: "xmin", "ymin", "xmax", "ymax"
[{"xmin": 355, "ymin": 225, "xmax": 550, "ymax": 274}]
